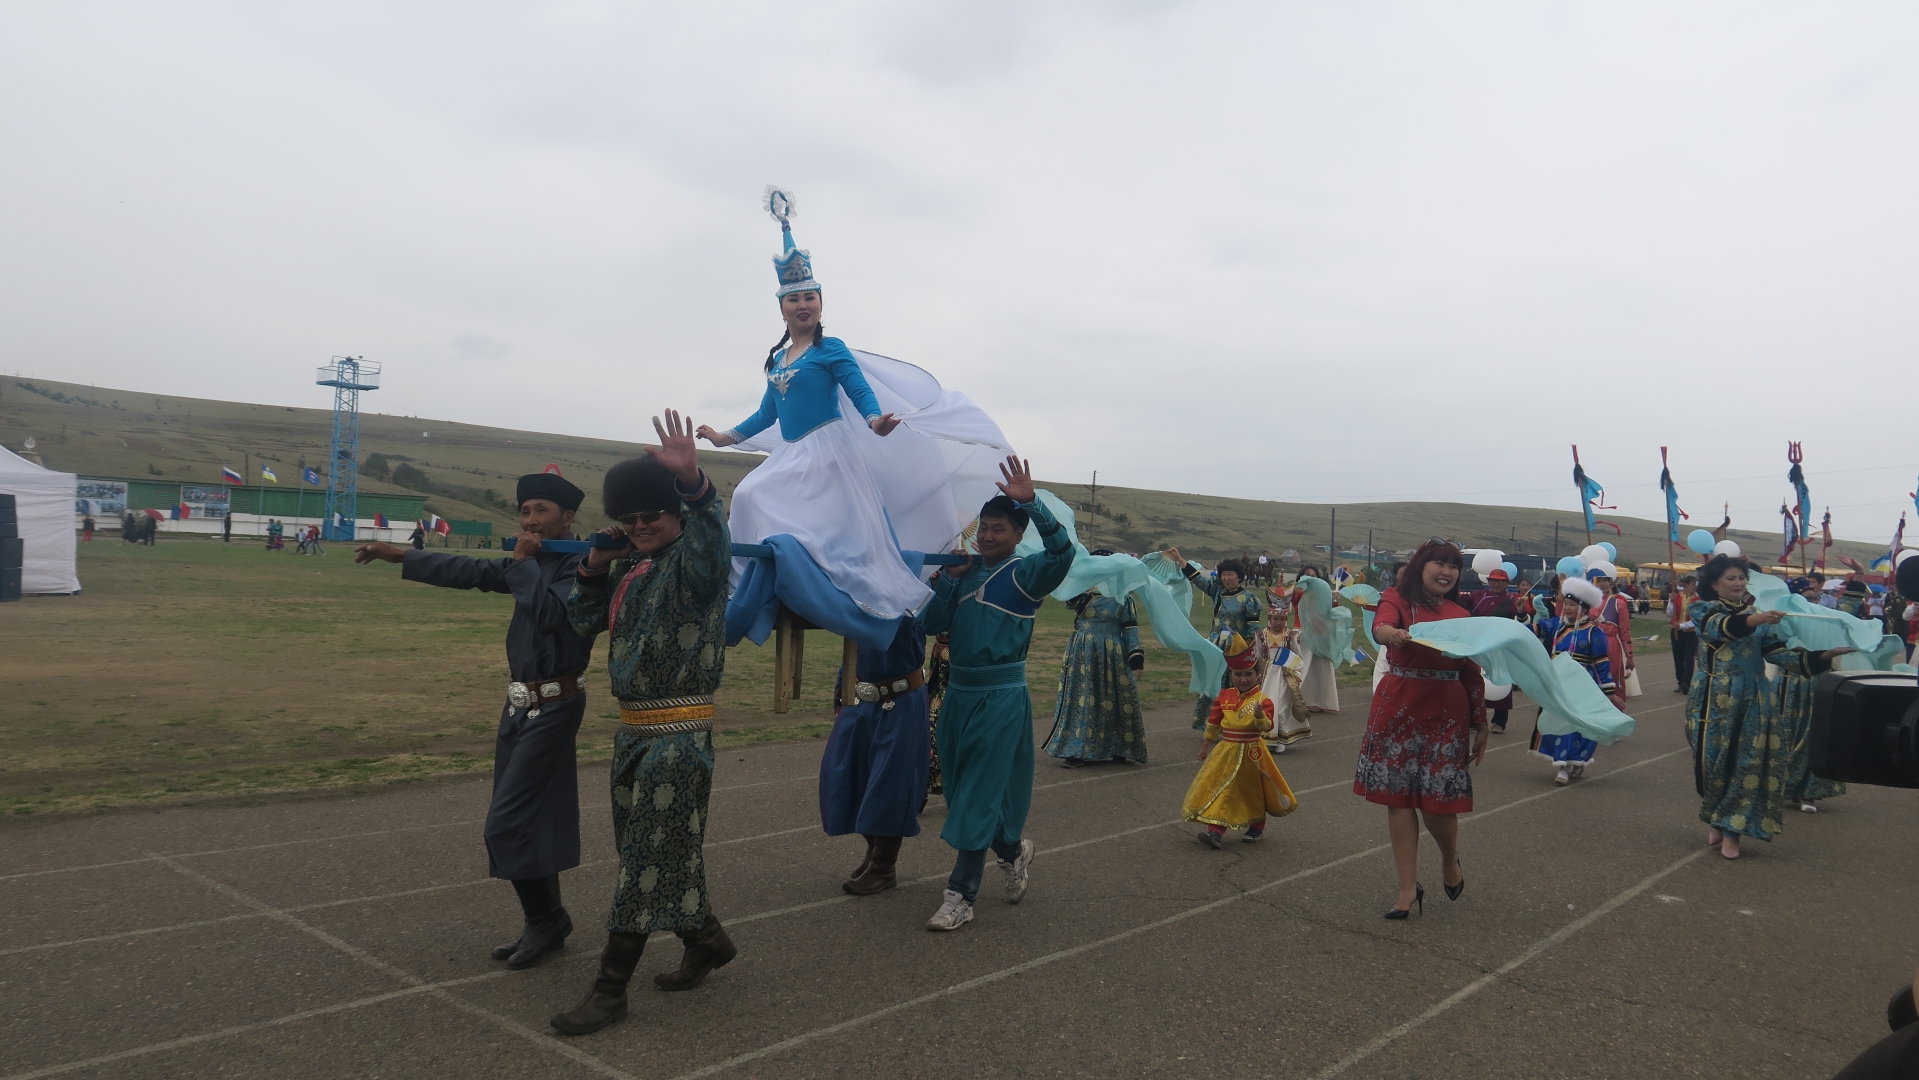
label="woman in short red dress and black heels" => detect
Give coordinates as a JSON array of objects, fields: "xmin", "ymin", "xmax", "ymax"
[{"xmin": 1353, "ymin": 539, "xmax": 1485, "ymax": 919}]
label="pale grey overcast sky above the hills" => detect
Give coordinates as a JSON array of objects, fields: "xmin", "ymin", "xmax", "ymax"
[{"xmin": 0, "ymin": 0, "xmax": 1919, "ymax": 541}]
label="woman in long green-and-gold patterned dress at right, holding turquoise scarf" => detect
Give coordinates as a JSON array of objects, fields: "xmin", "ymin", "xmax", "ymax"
[{"xmin": 1685, "ymin": 554, "xmax": 1787, "ymax": 859}]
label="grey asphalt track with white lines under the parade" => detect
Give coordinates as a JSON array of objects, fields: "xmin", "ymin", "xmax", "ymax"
[{"xmin": 0, "ymin": 646, "xmax": 1919, "ymax": 1080}]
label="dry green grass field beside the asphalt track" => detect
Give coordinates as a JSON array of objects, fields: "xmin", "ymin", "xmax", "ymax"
[{"xmin": 11, "ymin": 539, "xmax": 1320, "ymax": 813}]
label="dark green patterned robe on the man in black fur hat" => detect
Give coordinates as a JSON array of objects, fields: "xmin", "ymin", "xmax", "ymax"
[{"xmin": 566, "ymin": 483, "xmax": 731, "ymax": 934}]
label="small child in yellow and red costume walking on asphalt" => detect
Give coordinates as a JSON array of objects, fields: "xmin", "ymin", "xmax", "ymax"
[{"xmin": 1180, "ymin": 635, "xmax": 1299, "ymax": 848}]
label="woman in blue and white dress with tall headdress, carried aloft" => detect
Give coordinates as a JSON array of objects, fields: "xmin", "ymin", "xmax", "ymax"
[{"xmin": 699, "ymin": 188, "xmax": 1011, "ymax": 633}]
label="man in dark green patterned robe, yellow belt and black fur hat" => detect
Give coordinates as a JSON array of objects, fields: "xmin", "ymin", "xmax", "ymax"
[{"xmin": 551, "ymin": 411, "xmax": 737, "ymax": 1034}]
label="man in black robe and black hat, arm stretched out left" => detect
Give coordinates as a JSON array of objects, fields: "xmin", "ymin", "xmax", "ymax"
[{"xmin": 353, "ymin": 472, "xmax": 593, "ymax": 969}]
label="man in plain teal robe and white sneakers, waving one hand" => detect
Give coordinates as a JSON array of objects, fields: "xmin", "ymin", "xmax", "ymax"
[{"xmin": 919, "ymin": 458, "xmax": 1073, "ymax": 930}]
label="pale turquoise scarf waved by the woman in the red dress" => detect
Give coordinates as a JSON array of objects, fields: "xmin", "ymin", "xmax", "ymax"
[{"xmin": 1410, "ymin": 616, "xmax": 1633, "ymax": 746}]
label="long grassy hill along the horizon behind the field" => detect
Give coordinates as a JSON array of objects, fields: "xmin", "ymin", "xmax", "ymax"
[{"xmin": 0, "ymin": 378, "xmax": 1881, "ymax": 562}]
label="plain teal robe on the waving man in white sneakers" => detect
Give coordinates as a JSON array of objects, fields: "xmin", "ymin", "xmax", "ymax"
[{"xmin": 921, "ymin": 503, "xmax": 1073, "ymax": 852}]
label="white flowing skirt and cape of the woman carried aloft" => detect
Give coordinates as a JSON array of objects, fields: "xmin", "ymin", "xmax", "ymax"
[{"xmin": 727, "ymin": 351, "xmax": 1011, "ymax": 618}]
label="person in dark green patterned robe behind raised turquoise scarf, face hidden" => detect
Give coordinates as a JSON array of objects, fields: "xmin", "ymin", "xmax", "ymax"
[{"xmin": 1046, "ymin": 583, "xmax": 1146, "ymax": 769}]
